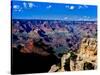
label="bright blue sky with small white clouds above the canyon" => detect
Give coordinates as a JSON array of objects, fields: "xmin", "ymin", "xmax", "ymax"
[{"xmin": 11, "ymin": 0, "xmax": 97, "ymax": 20}]
